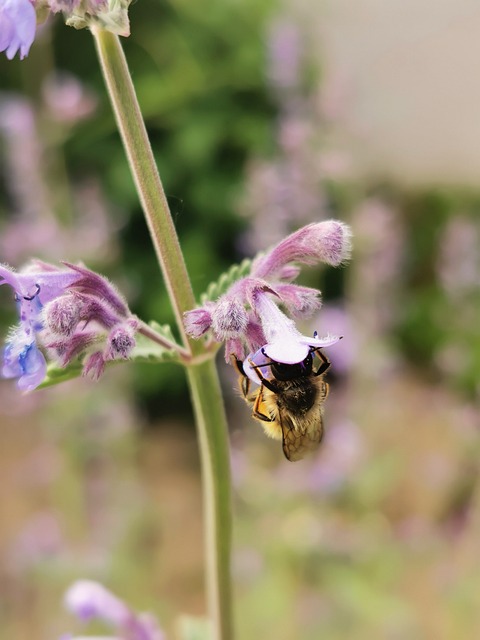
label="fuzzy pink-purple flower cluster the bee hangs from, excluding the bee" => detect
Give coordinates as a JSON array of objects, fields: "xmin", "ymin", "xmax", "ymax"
[{"xmin": 184, "ymin": 220, "xmax": 350, "ymax": 377}]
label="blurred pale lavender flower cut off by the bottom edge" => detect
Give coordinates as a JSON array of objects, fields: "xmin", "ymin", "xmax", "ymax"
[{"xmin": 65, "ymin": 580, "xmax": 165, "ymax": 640}]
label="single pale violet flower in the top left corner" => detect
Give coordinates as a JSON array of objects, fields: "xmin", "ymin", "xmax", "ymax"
[{"xmin": 0, "ymin": 0, "xmax": 37, "ymax": 60}]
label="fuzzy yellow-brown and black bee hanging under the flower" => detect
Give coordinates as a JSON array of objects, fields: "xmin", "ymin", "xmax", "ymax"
[{"xmin": 232, "ymin": 347, "xmax": 330, "ymax": 462}]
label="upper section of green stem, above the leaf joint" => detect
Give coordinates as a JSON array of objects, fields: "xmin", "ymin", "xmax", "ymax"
[{"xmin": 92, "ymin": 29, "xmax": 194, "ymax": 352}]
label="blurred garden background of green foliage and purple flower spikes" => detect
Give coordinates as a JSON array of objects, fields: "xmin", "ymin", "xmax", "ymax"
[{"xmin": 0, "ymin": 0, "xmax": 480, "ymax": 640}]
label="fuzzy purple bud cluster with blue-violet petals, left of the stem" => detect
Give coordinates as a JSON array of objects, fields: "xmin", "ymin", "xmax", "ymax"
[{"xmin": 0, "ymin": 262, "xmax": 138, "ymax": 391}]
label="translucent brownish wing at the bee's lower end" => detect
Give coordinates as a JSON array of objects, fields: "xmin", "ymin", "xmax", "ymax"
[{"xmin": 280, "ymin": 408, "xmax": 323, "ymax": 462}]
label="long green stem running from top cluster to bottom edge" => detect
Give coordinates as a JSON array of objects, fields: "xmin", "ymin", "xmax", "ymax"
[{"xmin": 92, "ymin": 29, "xmax": 233, "ymax": 640}]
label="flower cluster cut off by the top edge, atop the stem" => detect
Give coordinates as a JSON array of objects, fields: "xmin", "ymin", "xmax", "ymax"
[{"xmin": 0, "ymin": 0, "xmax": 130, "ymax": 60}]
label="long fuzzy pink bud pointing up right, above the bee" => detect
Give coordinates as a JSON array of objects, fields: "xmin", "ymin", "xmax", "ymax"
[{"xmin": 252, "ymin": 220, "xmax": 351, "ymax": 280}]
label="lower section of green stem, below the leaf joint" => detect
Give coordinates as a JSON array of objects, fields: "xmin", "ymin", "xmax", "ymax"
[{"xmin": 188, "ymin": 360, "xmax": 233, "ymax": 640}]
